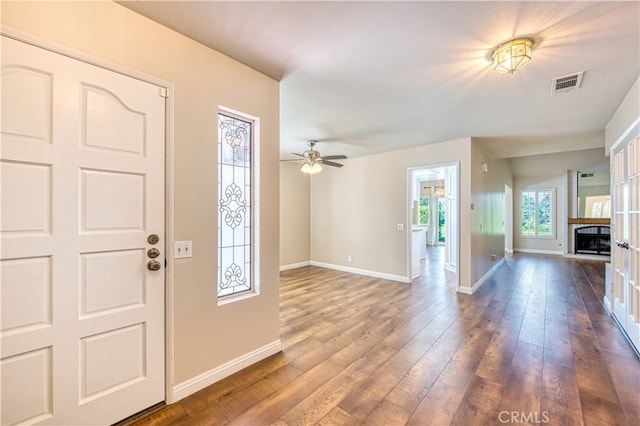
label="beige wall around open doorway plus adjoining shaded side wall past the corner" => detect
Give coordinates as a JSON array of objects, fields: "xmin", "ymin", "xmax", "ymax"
[{"xmin": 304, "ymin": 138, "xmax": 512, "ymax": 291}]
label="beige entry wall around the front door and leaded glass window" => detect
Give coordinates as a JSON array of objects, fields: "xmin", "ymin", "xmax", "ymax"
[{"xmin": 2, "ymin": 1, "xmax": 279, "ymax": 392}]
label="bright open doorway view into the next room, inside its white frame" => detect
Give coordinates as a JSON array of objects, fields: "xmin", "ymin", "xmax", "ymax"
[{"xmin": 408, "ymin": 163, "xmax": 459, "ymax": 285}]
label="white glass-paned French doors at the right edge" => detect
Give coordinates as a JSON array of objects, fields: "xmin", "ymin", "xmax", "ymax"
[{"xmin": 611, "ymin": 131, "xmax": 640, "ymax": 349}]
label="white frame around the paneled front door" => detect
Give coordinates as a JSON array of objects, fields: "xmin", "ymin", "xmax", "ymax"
[{"xmin": 0, "ymin": 25, "xmax": 174, "ymax": 404}]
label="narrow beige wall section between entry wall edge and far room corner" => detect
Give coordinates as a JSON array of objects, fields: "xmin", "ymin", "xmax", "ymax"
[{"xmin": 280, "ymin": 161, "xmax": 312, "ymax": 268}]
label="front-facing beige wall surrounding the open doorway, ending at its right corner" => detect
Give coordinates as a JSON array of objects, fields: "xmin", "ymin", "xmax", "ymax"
[{"xmin": 311, "ymin": 138, "xmax": 480, "ymax": 285}]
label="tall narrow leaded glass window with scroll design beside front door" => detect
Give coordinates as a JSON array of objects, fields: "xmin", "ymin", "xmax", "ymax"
[{"xmin": 218, "ymin": 113, "xmax": 253, "ymax": 298}]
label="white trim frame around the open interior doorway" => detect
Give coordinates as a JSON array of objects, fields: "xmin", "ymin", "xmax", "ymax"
[{"xmin": 405, "ymin": 161, "xmax": 460, "ymax": 291}]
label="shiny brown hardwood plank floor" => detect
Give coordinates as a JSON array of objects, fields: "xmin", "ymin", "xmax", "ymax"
[{"xmin": 136, "ymin": 248, "xmax": 640, "ymax": 426}]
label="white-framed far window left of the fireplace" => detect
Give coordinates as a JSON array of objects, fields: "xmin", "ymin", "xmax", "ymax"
[{"xmin": 520, "ymin": 189, "xmax": 554, "ymax": 237}]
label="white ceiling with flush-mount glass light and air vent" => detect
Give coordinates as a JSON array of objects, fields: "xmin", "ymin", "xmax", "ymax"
[{"xmin": 119, "ymin": 1, "xmax": 640, "ymax": 159}]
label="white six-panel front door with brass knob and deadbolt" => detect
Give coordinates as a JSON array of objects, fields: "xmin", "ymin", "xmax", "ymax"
[{"xmin": 0, "ymin": 36, "xmax": 165, "ymax": 425}]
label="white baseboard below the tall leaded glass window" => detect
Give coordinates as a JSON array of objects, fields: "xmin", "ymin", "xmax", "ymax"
[{"xmin": 167, "ymin": 339, "xmax": 282, "ymax": 404}]
